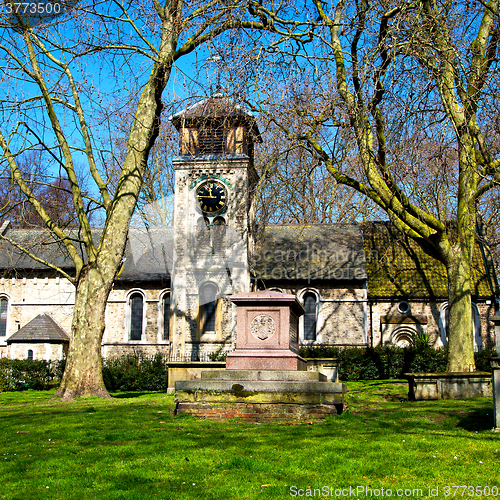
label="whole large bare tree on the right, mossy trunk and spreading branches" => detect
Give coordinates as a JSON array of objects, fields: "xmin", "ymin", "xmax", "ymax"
[{"xmin": 233, "ymin": 0, "xmax": 500, "ymax": 372}]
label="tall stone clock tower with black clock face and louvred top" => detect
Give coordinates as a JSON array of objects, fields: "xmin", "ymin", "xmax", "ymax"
[{"xmin": 170, "ymin": 93, "xmax": 262, "ymax": 360}]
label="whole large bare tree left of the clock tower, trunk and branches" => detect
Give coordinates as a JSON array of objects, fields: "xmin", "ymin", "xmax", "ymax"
[{"xmin": 0, "ymin": 0, "xmax": 272, "ymax": 399}]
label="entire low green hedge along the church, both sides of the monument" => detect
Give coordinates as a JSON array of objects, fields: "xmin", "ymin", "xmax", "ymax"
[{"xmin": 0, "ymin": 344, "xmax": 495, "ymax": 392}]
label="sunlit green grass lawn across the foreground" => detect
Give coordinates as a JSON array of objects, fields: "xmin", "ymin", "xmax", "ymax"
[{"xmin": 0, "ymin": 381, "xmax": 500, "ymax": 500}]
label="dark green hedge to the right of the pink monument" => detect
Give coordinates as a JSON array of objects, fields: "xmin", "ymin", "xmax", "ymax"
[{"xmin": 300, "ymin": 345, "xmax": 495, "ymax": 381}]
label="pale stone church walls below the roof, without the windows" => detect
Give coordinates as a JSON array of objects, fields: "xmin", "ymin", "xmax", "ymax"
[{"xmin": 0, "ymin": 273, "xmax": 495, "ymax": 360}]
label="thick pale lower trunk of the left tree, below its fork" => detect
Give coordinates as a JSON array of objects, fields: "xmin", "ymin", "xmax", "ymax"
[{"xmin": 54, "ymin": 267, "xmax": 114, "ymax": 401}]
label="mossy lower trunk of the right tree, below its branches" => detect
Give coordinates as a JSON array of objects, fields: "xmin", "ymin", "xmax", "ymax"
[{"xmin": 446, "ymin": 251, "xmax": 475, "ymax": 372}]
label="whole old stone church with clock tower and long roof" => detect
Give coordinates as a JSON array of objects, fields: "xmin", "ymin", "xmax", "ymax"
[{"xmin": 0, "ymin": 94, "xmax": 497, "ymax": 361}]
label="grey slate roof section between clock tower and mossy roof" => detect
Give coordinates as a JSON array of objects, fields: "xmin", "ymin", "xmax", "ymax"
[{"xmin": 250, "ymin": 224, "xmax": 366, "ymax": 281}]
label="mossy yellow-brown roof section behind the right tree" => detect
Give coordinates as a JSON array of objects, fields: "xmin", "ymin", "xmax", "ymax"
[{"xmin": 363, "ymin": 222, "xmax": 492, "ymax": 298}]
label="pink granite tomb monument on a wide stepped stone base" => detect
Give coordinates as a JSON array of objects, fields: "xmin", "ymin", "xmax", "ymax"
[{"xmin": 175, "ymin": 291, "xmax": 346, "ymax": 421}]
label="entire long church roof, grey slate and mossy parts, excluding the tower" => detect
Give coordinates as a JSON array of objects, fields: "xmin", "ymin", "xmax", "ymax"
[{"xmin": 0, "ymin": 222, "xmax": 493, "ymax": 299}]
